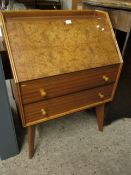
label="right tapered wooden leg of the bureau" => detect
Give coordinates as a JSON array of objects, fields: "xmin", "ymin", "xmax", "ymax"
[{"xmin": 96, "ymin": 104, "xmax": 104, "ymax": 131}]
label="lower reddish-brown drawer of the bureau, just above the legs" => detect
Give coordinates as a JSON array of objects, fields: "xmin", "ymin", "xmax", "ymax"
[{"xmin": 24, "ymin": 84, "xmax": 113, "ymax": 124}]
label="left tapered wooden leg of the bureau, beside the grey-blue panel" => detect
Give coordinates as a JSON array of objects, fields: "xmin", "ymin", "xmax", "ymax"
[{"xmin": 28, "ymin": 126, "xmax": 35, "ymax": 159}]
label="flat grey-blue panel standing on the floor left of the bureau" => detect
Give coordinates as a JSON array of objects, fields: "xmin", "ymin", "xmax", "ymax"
[{"xmin": 0, "ymin": 57, "xmax": 19, "ymax": 159}]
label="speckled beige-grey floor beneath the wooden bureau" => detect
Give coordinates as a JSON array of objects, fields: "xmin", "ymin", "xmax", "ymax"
[{"xmin": 0, "ymin": 111, "xmax": 131, "ymax": 175}]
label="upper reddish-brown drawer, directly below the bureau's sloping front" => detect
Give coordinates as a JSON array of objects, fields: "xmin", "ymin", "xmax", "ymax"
[{"xmin": 20, "ymin": 65, "xmax": 118, "ymax": 104}]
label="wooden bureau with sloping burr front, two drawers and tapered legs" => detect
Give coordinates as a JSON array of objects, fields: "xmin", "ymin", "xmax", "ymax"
[{"xmin": 1, "ymin": 10, "xmax": 122, "ymax": 158}]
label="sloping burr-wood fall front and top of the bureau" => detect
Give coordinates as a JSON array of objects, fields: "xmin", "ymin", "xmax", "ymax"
[{"xmin": 2, "ymin": 11, "xmax": 122, "ymax": 82}]
